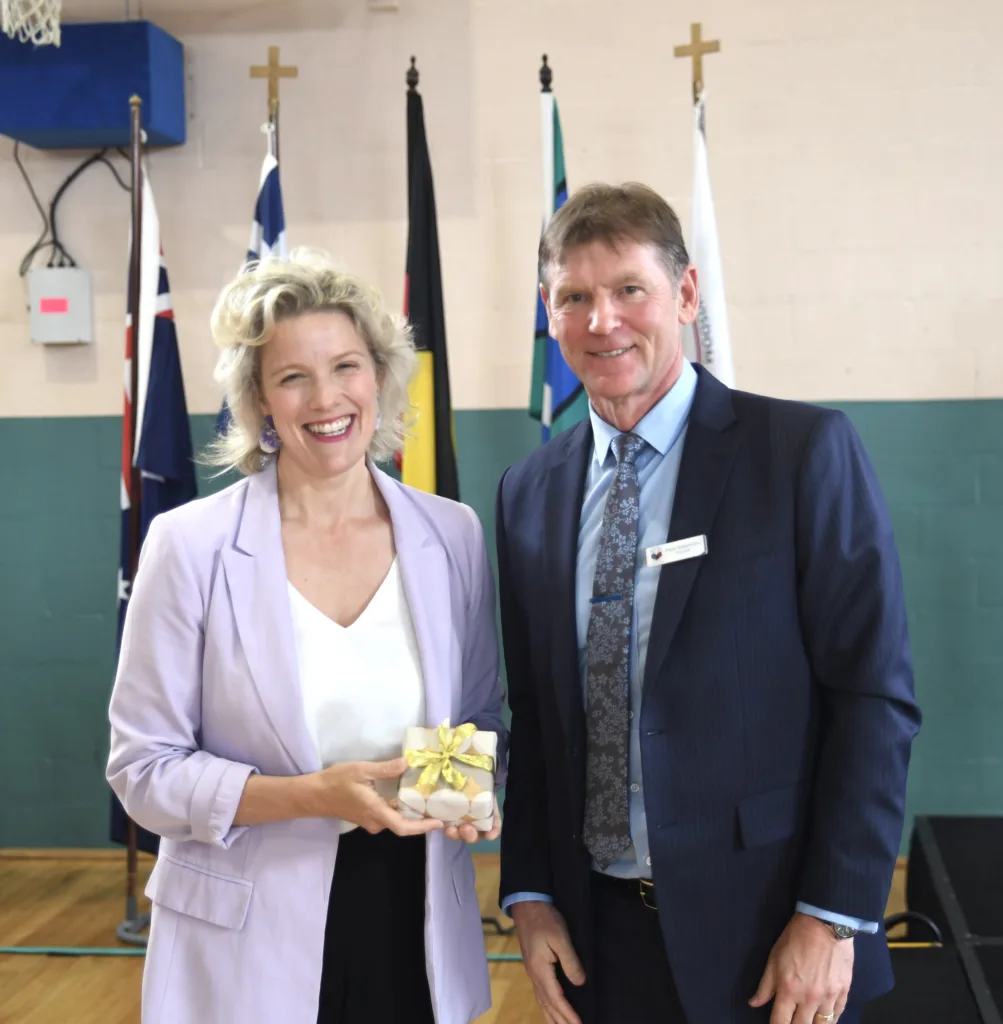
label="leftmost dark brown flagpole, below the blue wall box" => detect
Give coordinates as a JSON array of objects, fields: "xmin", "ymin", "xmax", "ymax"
[{"xmin": 119, "ymin": 95, "xmax": 145, "ymax": 945}]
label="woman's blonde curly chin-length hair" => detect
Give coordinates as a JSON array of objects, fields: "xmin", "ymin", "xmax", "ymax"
[{"xmin": 202, "ymin": 249, "xmax": 418, "ymax": 475}]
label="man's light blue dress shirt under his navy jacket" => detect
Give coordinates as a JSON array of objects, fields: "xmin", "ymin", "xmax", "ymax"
[{"xmin": 502, "ymin": 362, "xmax": 878, "ymax": 932}]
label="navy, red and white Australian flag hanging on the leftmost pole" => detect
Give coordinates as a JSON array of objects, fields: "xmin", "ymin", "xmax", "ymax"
[{"xmin": 111, "ymin": 170, "xmax": 197, "ymax": 853}]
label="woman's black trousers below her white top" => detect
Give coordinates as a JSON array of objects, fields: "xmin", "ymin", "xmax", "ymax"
[{"xmin": 317, "ymin": 828, "xmax": 434, "ymax": 1024}]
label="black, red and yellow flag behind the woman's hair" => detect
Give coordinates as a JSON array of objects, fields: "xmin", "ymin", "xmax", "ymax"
[{"xmin": 402, "ymin": 89, "xmax": 460, "ymax": 500}]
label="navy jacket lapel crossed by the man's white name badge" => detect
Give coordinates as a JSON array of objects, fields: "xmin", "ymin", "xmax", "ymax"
[{"xmin": 643, "ymin": 367, "xmax": 738, "ymax": 693}]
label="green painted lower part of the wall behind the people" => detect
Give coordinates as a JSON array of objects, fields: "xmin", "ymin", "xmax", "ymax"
[{"xmin": 0, "ymin": 401, "xmax": 1003, "ymax": 847}]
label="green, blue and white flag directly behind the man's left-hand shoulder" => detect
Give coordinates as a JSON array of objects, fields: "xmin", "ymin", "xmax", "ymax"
[{"xmin": 530, "ymin": 91, "xmax": 588, "ymax": 441}]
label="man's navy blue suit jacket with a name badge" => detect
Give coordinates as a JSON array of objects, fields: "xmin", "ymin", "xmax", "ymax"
[{"xmin": 497, "ymin": 368, "xmax": 920, "ymax": 1024}]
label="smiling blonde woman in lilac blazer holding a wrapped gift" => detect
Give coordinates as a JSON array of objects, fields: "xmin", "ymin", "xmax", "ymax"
[{"xmin": 108, "ymin": 253, "xmax": 504, "ymax": 1024}]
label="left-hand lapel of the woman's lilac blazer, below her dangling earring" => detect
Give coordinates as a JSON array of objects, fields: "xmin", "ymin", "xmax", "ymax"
[{"xmin": 222, "ymin": 463, "xmax": 321, "ymax": 772}]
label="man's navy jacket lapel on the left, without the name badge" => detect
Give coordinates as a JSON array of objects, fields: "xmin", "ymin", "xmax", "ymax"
[{"xmin": 543, "ymin": 420, "xmax": 592, "ymax": 762}]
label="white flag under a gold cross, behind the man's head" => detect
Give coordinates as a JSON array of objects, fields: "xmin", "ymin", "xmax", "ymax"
[{"xmin": 683, "ymin": 93, "xmax": 735, "ymax": 387}]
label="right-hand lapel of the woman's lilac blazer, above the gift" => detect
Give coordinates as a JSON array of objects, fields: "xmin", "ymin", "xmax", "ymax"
[{"xmin": 370, "ymin": 465, "xmax": 448, "ymax": 739}]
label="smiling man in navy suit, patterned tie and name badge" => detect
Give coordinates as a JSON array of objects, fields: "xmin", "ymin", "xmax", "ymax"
[{"xmin": 497, "ymin": 184, "xmax": 920, "ymax": 1024}]
